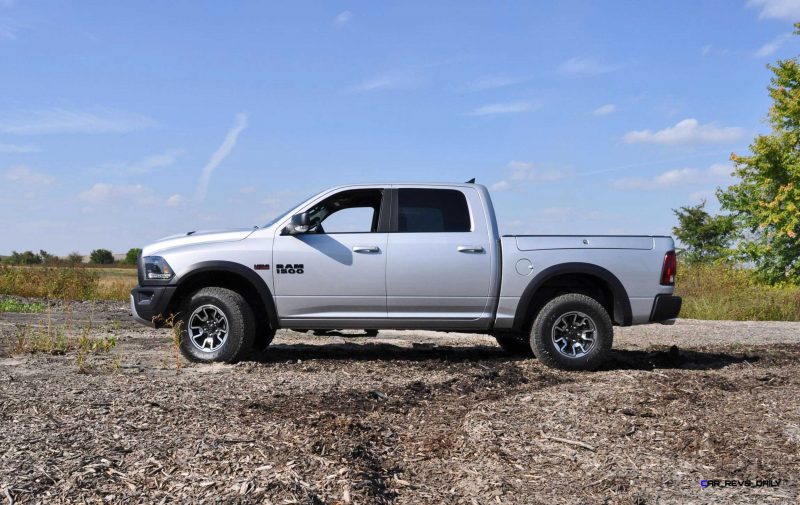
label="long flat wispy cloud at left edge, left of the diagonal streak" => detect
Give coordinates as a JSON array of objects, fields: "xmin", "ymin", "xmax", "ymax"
[{"xmin": 0, "ymin": 109, "xmax": 156, "ymax": 135}]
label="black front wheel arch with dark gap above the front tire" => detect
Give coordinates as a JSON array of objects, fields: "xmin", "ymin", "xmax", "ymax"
[{"xmin": 166, "ymin": 261, "xmax": 278, "ymax": 329}]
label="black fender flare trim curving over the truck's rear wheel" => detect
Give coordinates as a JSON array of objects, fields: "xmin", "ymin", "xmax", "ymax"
[{"xmin": 514, "ymin": 262, "xmax": 633, "ymax": 330}]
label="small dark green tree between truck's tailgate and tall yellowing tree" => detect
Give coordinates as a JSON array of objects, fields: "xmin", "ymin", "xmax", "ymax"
[{"xmin": 672, "ymin": 200, "xmax": 736, "ymax": 263}]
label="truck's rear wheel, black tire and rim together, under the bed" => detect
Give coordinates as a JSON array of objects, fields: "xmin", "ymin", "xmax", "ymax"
[{"xmin": 530, "ymin": 293, "xmax": 614, "ymax": 370}]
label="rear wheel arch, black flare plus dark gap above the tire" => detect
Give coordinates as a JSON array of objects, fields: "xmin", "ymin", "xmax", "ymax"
[{"xmin": 513, "ymin": 262, "xmax": 633, "ymax": 331}]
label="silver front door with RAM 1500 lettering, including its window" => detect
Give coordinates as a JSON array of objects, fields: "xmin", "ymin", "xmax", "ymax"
[{"xmin": 272, "ymin": 188, "xmax": 388, "ymax": 322}]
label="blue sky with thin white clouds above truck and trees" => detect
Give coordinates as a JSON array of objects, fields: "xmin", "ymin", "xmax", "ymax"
[{"xmin": 0, "ymin": 0, "xmax": 800, "ymax": 254}]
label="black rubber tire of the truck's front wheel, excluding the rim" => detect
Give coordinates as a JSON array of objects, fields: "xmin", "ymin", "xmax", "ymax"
[{"xmin": 180, "ymin": 287, "xmax": 255, "ymax": 363}]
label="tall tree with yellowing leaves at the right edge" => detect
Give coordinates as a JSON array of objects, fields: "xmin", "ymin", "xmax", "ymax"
[{"xmin": 717, "ymin": 23, "xmax": 800, "ymax": 283}]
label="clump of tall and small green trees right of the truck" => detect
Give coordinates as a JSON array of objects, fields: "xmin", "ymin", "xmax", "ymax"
[{"xmin": 673, "ymin": 23, "xmax": 800, "ymax": 285}]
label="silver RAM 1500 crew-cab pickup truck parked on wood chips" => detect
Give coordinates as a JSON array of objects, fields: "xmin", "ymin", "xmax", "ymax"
[{"xmin": 130, "ymin": 183, "xmax": 681, "ymax": 370}]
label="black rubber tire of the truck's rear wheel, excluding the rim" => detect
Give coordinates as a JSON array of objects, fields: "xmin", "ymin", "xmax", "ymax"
[{"xmin": 530, "ymin": 293, "xmax": 614, "ymax": 370}]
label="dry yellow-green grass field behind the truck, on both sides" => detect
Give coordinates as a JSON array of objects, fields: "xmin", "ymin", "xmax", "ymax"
[{"xmin": 0, "ymin": 265, "xmax": 800, "ymax": 321}]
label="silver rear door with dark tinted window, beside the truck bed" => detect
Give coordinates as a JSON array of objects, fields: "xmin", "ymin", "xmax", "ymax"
[{"xmin": 386, "ymin": 186, "xmax": 492, "ymax": 328}]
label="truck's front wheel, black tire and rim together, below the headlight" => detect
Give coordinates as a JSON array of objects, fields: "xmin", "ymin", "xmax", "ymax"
[{"xmin": 181, "ymin": 288, "xmax": 255, "ymax": 363}]
